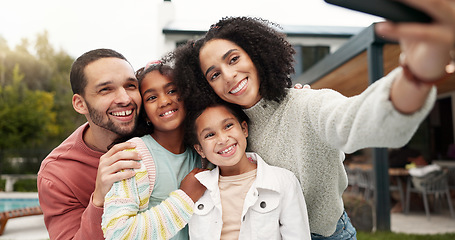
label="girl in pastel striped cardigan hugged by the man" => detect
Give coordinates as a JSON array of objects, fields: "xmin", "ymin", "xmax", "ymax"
[{"xmin": 102, "ymin": 61, "xmax": 205, "ymax": 240}]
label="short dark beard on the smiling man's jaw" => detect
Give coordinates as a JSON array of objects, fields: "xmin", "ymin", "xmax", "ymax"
[{"xmin": 87, "ymin": 103, "xmax": 137, "ymax": 136}]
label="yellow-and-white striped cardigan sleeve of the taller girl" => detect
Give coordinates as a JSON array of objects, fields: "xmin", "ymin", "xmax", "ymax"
[{"xmin": 102, "ymin": 159, "xmax": 194, "ymax": 239}]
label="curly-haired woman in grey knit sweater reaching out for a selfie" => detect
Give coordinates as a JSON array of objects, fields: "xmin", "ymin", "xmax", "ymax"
[{"xmin": 173, "ymin": 0, "xmax": 455, "ymax": 239}]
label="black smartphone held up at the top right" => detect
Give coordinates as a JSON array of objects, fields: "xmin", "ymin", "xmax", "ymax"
[{"xmin": 324, "ymin": 0, "xmax": 432, "ymax": 23}]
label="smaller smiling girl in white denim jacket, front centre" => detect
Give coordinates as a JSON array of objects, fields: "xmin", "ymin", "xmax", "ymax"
[{"xmin": 185, "ymin": 103, "xmax": 310, "ymax": 240}]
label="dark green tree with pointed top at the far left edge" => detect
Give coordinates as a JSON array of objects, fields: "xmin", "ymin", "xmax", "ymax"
[{"xmin": 0, "ymin": 65, "xmax": 58, "ymax": 172}]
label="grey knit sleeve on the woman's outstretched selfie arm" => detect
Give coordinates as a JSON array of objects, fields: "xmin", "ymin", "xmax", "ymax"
[{"xmin": 302, "ymin": 68, "xmax": 436, "ymax": 153}]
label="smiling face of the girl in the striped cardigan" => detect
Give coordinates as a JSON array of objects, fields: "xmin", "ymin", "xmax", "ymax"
[{"xmin": 141, "ymin": 71, "xmax": 185, "ymax": 133}]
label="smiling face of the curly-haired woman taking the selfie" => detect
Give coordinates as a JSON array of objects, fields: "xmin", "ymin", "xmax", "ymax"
[{"xmin": 199, "ymin": 39, "xmax": 261, "ymax": 108}]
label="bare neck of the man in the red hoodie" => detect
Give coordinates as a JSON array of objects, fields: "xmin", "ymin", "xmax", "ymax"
[{"xmin": 83, "ymin": 125, "xmax": 118, "ymax": 153}]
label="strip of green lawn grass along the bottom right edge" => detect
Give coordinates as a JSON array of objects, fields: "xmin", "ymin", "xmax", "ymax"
[{"xmin": 357, "ymin": 231, "xmax": 455, "ymax": 240}]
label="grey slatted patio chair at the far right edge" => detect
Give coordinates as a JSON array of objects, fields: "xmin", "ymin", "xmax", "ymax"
[{"xmin": 405, "ymin": 171, "xmax": 455, "ymax": 220}]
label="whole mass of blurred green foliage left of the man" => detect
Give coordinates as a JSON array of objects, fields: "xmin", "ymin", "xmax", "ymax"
[{"xmin": 0, "ymin": 32, "xmax": 85, "ymax": 173}]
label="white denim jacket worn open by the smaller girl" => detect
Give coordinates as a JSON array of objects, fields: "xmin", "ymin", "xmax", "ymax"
[{"xmin": 189, "ymin": 153, "xmax": 311, "ymax": 240}]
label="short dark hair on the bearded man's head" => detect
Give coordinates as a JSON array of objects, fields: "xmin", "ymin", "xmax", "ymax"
[{"xmin": 70, "ymin": 48, "xmax": 128, "ymax": 95}]
